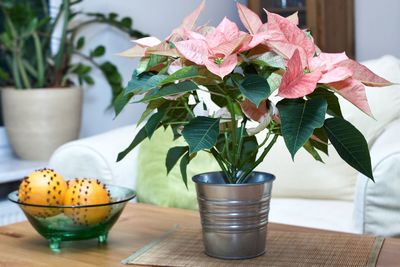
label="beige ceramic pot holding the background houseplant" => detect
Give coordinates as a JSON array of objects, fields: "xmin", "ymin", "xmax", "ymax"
[{"xmin": 1, "ymin": 88, "xmax": 82, "ymax": 160}]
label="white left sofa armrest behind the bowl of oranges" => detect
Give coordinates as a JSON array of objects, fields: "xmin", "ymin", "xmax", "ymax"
[{"xmin": 49, "ymin": 125, "xmax": 139, "ymax": 191}]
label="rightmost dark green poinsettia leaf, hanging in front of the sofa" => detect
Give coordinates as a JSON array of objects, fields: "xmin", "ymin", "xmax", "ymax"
[{"xmin": 324, "ymin": 118, "xmax": 374, "ymax": 180}]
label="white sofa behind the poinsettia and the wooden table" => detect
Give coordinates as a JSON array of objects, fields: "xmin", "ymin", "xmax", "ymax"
[{"xmin": 49, "ymin": 56, "xmax": 400, "ymax": 236}]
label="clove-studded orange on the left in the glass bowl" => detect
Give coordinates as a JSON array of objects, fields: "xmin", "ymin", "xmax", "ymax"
[{"xmin": 18, "ymin": 168, "xmax": 67, "ymax": 218}]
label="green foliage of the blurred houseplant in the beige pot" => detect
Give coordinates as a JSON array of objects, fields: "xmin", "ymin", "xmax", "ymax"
[{"xmin": 0, "ymin": 0, "xmax": 145, "ymax": 102}]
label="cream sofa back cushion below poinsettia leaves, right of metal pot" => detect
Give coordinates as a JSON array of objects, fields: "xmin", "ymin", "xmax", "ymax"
[{"xmin": 257, "ymin": 138, "xmax": 357, "ymax": 200}]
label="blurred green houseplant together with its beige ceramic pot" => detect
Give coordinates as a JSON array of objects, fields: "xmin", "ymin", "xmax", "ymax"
[{"xmin": 0, "ymin": 0, "xmax": 145, "ymax": 160}]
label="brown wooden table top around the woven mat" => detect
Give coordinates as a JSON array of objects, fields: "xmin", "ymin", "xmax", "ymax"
[{"xmin": 0, "ymin": 204, "xmax": 400, "ymax": 267}]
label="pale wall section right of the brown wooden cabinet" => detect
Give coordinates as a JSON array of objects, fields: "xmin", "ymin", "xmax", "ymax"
[{"xmin": 355, "ymin": 0, "xmax": 400, "ymax": 61}]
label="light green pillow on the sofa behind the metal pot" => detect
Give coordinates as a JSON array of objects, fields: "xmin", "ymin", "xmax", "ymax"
[{"xmin": 136, "ymin": 128, "xmax": 220, "ymax": 210}]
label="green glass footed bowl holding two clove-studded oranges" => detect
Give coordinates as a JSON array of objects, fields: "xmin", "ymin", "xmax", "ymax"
[{"xmin": 8, "ymin": 185, "xmax": 136, "ymax": 251}]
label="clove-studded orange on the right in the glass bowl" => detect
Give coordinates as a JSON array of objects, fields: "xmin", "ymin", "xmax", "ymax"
[{"xmin": 64, "ymin": 178, "xmax": 111, "ymax": 225}]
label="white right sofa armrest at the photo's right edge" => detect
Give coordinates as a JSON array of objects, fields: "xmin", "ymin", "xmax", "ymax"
[{"xmin": 354, "ymin": 120, "xmax": 400, "ymax": 236}]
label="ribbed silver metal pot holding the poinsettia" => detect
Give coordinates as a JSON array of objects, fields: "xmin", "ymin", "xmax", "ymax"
[{"xmin": 193, "ymin": 172, "xmax": 275, "ymax": 259}]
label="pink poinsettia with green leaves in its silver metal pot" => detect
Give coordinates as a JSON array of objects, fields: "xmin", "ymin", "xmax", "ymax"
[{"xmin": 115, "ymin": 3, "xmax": 391, "ymax": 258}]
